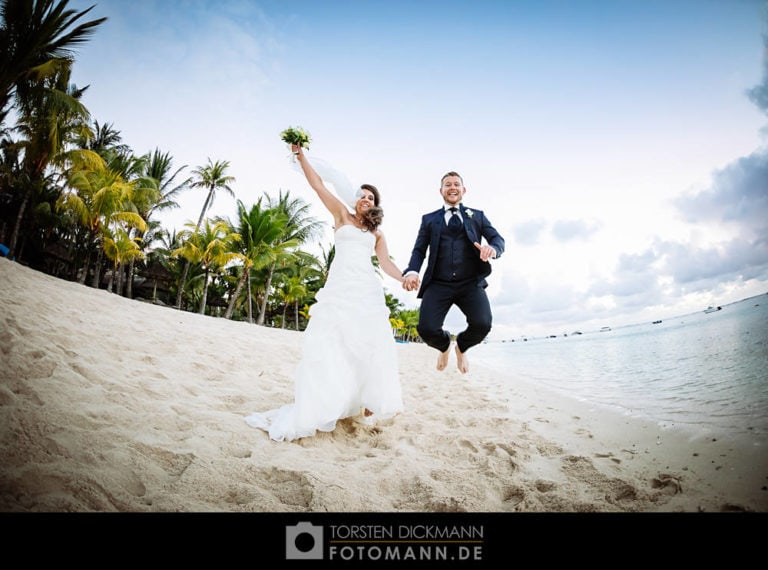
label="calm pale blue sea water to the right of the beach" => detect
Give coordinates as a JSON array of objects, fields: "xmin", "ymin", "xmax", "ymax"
[{"xmin": 472, "ymin": 294, "xmax": 768, "ymax": 441}]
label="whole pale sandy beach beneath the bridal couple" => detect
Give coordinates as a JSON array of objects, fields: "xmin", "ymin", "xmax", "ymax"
[{"xmin": 0, "ymin": 259, "xmax": 768, "ymax": 513}]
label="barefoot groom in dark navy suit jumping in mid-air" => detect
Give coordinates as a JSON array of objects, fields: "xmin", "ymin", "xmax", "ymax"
[{"xmin": 403, "ymin": 172, "xmax": 504, "ymax": 373}]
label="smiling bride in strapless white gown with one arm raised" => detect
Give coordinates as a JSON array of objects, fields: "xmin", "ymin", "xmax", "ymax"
[{"xmin": 245, "ymin": 141, "xmax": 403, "ymax": 441}]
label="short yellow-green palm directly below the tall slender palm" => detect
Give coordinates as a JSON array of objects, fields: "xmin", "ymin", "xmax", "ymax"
[{"xmin": 171, "ymin": 219, "xmax": 242, "ymax": 315}]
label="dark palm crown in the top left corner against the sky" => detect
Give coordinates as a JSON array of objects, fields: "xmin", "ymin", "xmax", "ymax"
[{"xmin": 0, "ymin": 0, "xmax": 106, "ymax": 124}]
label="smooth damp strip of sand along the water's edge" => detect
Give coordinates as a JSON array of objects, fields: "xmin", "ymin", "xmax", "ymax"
[{"xmin": 468, "ymin": 371, "xmax": 768, "ymax": 512}]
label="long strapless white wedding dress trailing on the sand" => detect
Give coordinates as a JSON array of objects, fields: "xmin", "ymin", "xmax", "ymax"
[{"xmin": 245, "ymin": 164, "xmax": 403, "ymax": 441}]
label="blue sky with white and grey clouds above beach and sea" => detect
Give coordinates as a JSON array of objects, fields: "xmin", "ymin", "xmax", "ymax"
[{"xmin": 68, "ymin": 0, "xmax": 768, "ymax": 340}]
